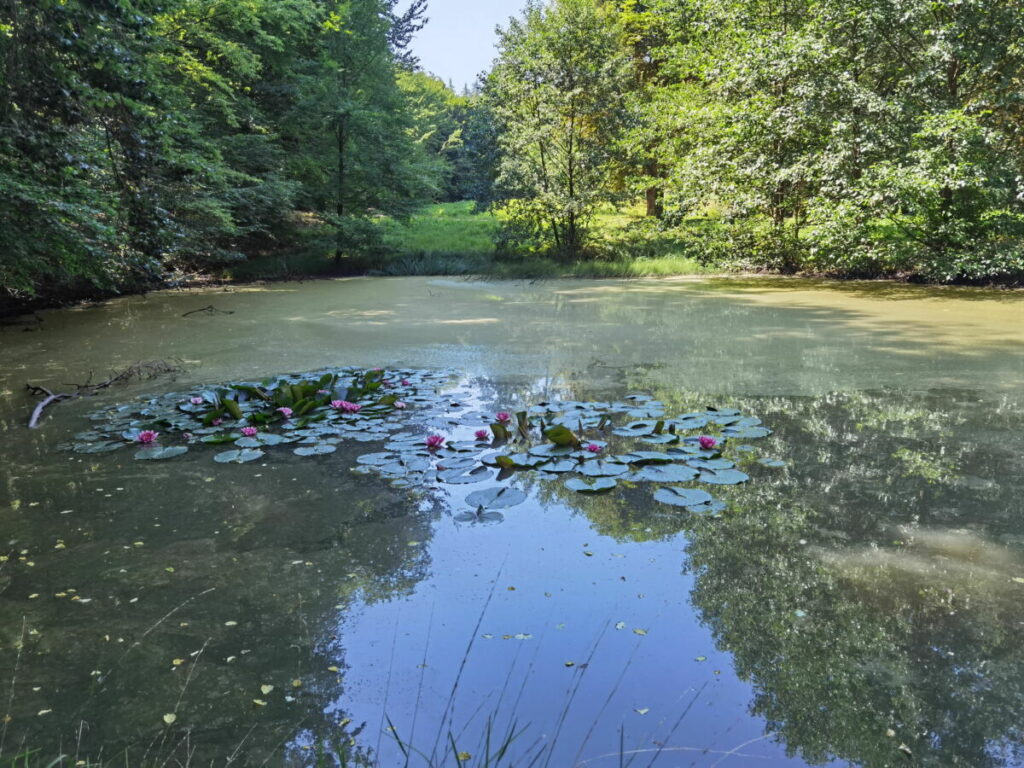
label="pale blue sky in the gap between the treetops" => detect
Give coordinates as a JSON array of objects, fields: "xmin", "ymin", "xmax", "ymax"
[{"xmin": 403, "ymin": 0, "xmax": 523, "ymax": 91}]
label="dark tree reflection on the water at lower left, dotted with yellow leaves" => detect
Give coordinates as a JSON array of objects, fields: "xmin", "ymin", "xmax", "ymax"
[{"xmin": 0, "ymin": 450, "xmax": 431, "ymax": 765}]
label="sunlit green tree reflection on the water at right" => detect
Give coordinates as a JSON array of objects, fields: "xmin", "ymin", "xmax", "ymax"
[{"xmin": 545, "ymin": 392, "xmax": 1024, "ymax": 768}]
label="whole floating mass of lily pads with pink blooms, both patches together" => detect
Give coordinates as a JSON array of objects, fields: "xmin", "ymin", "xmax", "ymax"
[{"xmin": 66, "ymin": 368, "xmax": 783, "ymax": 515}]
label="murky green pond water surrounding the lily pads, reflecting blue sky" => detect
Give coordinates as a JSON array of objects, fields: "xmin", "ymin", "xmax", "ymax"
[{"xmin": 0, "ymin": 279, "xmax": 1024, "ymax": 768}]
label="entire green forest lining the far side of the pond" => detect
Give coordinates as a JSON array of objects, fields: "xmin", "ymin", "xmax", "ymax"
[{"xmin": 0, "ymin": 0, "xmax": 1024, "ymax": 309}]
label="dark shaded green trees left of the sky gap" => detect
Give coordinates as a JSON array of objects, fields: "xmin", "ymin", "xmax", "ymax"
[{"xmin": 0, "ymin": 0, "xmax": 491, "ymax": 297}]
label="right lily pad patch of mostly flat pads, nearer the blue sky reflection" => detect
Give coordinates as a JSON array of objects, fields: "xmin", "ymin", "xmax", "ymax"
[{"xmin": 356, "ymin": 394, "xmax": 783, "ymax": 514}]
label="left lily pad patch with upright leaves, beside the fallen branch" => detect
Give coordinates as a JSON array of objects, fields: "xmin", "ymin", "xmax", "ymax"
[{"xmin": 63, "ymin": 368, "xmax": 451, "ymax": 464}]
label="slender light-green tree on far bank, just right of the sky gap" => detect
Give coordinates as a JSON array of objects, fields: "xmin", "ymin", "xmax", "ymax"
[{"xmin": 487, "ymin": 0, "xmax": 628, "ymax": 258}]
